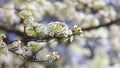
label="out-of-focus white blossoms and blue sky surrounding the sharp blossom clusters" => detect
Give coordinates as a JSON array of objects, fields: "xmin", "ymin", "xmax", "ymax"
[{"xmin": 0, "ymin": 0, "xmax": 120, "ymax": 68}]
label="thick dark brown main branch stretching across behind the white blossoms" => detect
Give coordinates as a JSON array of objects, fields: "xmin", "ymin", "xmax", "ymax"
[{"xmin": 0, "ymin": 19, "xmax": 120, "ymax": 43}]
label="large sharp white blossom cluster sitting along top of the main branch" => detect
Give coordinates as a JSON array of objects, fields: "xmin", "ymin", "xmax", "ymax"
[{"xmin": 19, "ymin": 10, "xmax": 82, "ymax": 41}]
